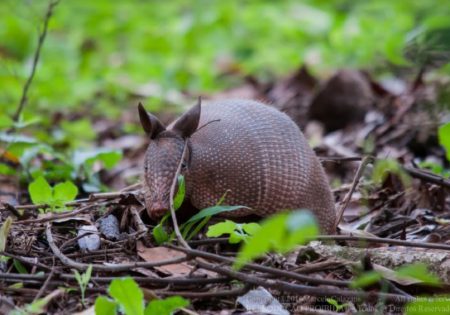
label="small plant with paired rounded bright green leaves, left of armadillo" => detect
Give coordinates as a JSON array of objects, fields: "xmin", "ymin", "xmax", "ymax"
[{"xmin": 28, "ymin": 176, "xmax": 78, "ymax": 212}]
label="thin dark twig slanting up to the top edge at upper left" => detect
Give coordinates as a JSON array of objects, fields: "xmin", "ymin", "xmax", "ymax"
[{"xmin": 13, "ymin": 0, "xmax": 60, "ymax": 122}]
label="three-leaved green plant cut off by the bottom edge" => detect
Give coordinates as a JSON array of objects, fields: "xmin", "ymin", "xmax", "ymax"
[{"xmin": 95, "ymin": 277, "xmax": 189, "ymax": 315}]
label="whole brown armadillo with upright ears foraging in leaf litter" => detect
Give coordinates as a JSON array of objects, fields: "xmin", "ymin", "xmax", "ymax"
[{"xmin": 139, "ymin": 99, "xmax": 336, "ymax": 233}]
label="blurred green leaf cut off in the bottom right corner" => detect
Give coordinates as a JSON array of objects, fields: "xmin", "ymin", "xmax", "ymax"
[{"xmin": 405, "ymin": 295, "xmax": 450, "ymax": 315}]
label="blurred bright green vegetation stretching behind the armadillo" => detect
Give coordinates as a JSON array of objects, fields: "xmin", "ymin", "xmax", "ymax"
[{"xmin": 0, "ymin": 0, "xmax": 450, "ymax": 191}]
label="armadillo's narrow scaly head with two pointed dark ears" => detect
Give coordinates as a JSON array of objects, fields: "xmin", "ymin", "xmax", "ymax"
[{"xmin": 138, "ymin": 101, "xmax": 200, "ymax": 219}]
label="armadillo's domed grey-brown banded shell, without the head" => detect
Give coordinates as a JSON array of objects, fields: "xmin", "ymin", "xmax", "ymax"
[{"xmin": 186, "ymin": 100, "xmax": 336, "ymax": 233}]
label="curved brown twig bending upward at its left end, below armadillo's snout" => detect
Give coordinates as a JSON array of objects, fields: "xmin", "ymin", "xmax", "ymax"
[{"xmin": 45, "ymin": 223, "xmax": 189, "ymax": 272}]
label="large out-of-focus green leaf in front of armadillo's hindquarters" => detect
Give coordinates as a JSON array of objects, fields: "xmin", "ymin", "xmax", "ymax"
[{"xmin": 233, "ymin": 210, "xmax": 319, "ymax": 269}]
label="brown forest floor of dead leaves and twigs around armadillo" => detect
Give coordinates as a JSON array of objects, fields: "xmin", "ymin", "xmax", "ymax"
[{"xmin": 0, "ymin": 62, "xmax": 450, "ymax": 314}]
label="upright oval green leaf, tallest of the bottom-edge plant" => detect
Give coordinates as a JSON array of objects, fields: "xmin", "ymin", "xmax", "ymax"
[{"xmin": 108, "ymin": 277, "xmax": 144, "ymax": 315}]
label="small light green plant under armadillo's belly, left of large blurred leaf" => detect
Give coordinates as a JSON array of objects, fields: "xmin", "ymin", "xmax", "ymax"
[{"xmin": 206, "ymin": 220, "xmax": 261, "ymax": 244}]
